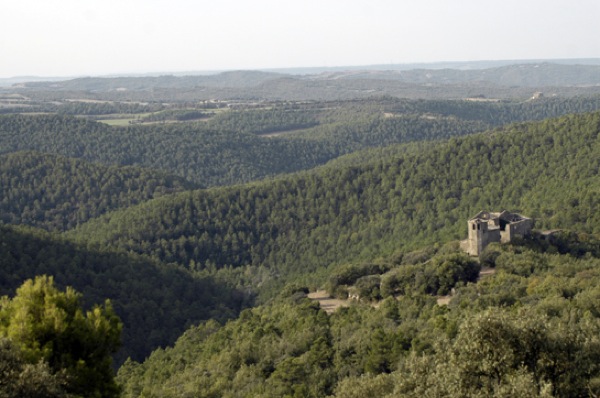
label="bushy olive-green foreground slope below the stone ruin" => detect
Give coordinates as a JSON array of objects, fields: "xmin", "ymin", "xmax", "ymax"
[{"xmin": 118, "ymin": 235, "xmax": 600, "ymax": 398}]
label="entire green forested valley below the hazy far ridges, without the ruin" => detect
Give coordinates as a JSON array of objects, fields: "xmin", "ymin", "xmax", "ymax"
[{"xmin": 0, "ymin": 67, "xmax": 600, "ymax": 397}]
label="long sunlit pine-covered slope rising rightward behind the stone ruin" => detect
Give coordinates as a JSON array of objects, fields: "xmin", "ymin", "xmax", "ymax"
[{"xmin": 69, "ymin": 113, "xmax": 600, "ymax": 296}]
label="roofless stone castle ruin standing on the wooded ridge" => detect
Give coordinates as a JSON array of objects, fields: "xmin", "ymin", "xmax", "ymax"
[{"xmin": 461, "ymin": 210, "xmax": 533, "ymax": 256}]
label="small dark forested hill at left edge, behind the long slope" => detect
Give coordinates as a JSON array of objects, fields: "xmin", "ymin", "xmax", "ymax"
[{"xmin": 0, "ymin": 152, "xmax": 194, "ymax": 231}]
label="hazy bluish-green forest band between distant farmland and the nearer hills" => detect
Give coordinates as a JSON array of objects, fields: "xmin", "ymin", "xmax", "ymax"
[{"xmin": 0, "ymin": 97, "xmax": 600, "ymax": 187}]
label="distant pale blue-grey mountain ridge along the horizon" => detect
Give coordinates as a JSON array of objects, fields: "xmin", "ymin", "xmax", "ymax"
[{"xmin": 7, "ymin": 60, "xmax": 600, "ymax": 97}]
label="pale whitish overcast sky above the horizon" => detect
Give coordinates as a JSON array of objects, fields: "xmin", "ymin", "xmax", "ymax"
[{"xmin": 0, "ymin": 0, "xmax": 600, "ymax": 78}]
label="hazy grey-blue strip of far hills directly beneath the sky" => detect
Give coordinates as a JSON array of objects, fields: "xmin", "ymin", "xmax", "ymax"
[{"xmin": 5, "ymin": 59, "xmax": 600, "ymax": 101}]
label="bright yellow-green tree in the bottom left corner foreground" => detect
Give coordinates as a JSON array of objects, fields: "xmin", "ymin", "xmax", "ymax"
[{"xmin": 0, "ymin": 276, "xmax": 122, "ymax": 397}]
